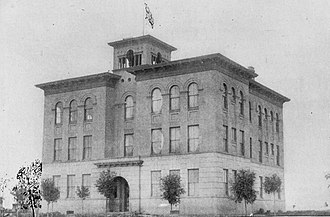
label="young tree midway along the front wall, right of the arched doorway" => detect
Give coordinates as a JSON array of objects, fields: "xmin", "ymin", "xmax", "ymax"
[{"xmin": 160, "ymin": 174, "xmax": 185, "ymax": 211}]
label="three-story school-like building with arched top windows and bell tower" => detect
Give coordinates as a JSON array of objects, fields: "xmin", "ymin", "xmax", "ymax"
[{"xmin": 37, "ymin": 35, "xmax": 289, "ymax": 214}]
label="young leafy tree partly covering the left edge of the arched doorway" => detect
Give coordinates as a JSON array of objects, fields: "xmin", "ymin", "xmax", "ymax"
[{"xmin": 95, "ymin": 169, "xmax": 117, "ymax": 212}]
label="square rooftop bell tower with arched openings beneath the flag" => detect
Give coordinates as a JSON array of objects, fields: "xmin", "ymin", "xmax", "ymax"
[{"xmin": 108, "ymin": 35, "xmax": 177, "ymax": 70}]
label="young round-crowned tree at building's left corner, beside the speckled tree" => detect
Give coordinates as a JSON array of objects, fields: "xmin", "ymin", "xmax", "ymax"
[{"xmin": 41, "ymin": 179, "xmax": 60, "ymax": 216}]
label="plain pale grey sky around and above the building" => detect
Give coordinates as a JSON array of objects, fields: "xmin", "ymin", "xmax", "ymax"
[{"xmin": 0, "ymin": 0, "xmax": 330, "ymax": 209}]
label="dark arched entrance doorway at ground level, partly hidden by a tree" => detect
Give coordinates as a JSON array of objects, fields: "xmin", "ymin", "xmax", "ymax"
[{"xmin": 107, "ymin": 176, "xmax": 129, "ymax": 212}]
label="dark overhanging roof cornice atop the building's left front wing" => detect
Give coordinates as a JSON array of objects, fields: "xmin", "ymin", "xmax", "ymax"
[{"xmin": 35, "ymin": 72, "xmax": 121, "ymax": 95}]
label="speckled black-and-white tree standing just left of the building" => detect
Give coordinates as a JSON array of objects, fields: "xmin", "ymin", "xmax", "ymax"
[{"xmin": 13, "ymin": 160, "xmax": 42, "ymax": 217}]
